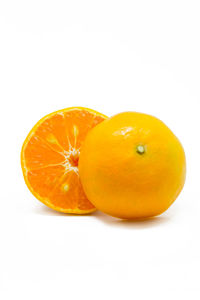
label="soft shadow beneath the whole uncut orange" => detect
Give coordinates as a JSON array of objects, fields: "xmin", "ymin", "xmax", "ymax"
[{"xmin": 93, "ymin": 211, "xmax": 171, "ymax": 229}]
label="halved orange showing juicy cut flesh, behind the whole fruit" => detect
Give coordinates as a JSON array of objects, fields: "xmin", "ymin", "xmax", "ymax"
[{"xmin": 21, "ymin": 107, "xmax": 106, "ymax": 214}]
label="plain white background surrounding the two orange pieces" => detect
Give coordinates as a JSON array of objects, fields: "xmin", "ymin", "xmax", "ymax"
[{"xmin": 0, "ymin": 0, "xmax": 200, "ymax": 300}]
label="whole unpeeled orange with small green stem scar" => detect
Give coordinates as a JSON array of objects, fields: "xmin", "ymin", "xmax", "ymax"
[{"xmin": 79, "ymin": 112, "xmax": 186, "ymax": 219}]
